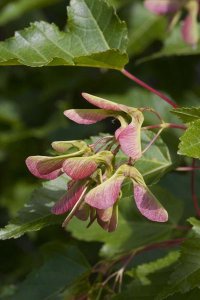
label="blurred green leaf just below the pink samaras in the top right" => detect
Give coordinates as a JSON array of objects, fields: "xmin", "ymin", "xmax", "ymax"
[{"xmin": 138, "ymin": 26, "xmax": 200, "ymax": 63}]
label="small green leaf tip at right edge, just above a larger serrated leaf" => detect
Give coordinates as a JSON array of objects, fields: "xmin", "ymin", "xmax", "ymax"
[{"xmin": 171, "ymin": 107, "xmax": 200, "ymax": 123}]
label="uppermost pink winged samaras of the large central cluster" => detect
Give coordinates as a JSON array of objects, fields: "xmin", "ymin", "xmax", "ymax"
[{"xmin": 64, "ymin": 93, "xmax": 144, "ymax": 160}]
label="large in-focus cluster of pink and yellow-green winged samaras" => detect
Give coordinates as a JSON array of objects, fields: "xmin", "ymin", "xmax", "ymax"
[{"xmin": 26, "ymin": 93, "xmax": 168, "ymax": 231}]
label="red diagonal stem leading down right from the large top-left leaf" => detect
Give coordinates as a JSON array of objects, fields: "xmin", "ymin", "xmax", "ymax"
[{"xmin": 121, "ymin": 69, "xmax": 178, "ymax": 108}]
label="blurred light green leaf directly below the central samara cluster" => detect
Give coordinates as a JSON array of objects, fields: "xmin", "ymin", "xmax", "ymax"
[{"xmin": 67, "ymin": 214, "xmax": 172, "ymax": 257}]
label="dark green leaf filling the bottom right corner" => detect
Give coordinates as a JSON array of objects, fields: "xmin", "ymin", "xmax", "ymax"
[{"xmin": 158, "ymin": 218, "xmax": 200, "ymax": 299}]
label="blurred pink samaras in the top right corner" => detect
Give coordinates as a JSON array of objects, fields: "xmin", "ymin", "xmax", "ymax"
[{"xmin": 144, "ymin": 0, "xmax": 200, "ymax": 45}]
